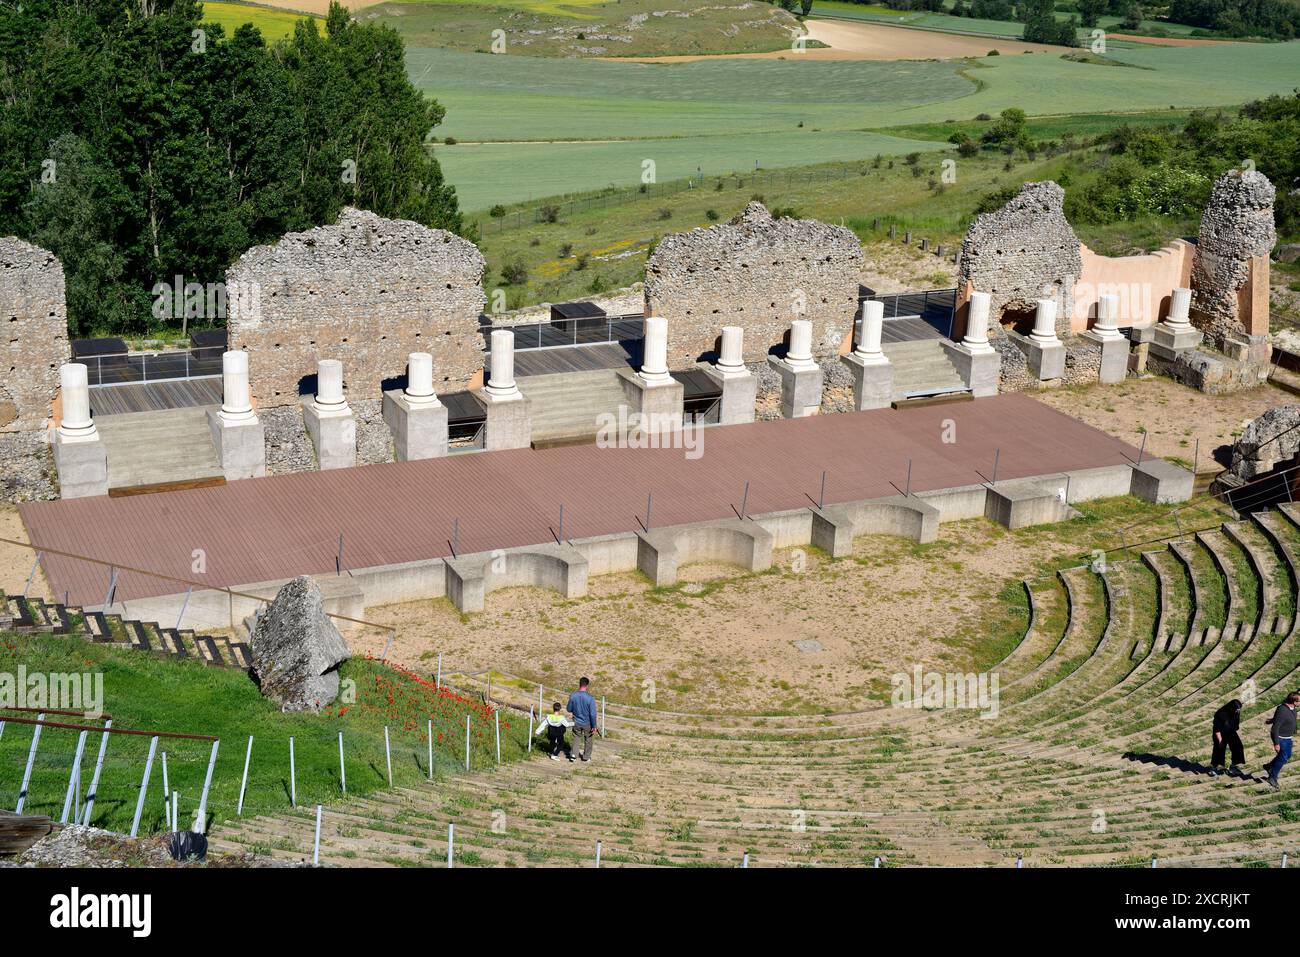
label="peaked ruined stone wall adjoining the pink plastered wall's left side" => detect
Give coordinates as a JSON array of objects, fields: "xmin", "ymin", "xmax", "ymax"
[{"xmin": 957, "ymin": 181, "xmax": 1083, "ymax": 338}]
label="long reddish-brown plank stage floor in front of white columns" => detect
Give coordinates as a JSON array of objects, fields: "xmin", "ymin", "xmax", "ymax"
[{"xmin": 21, "ymin": 394, "xmax": 1138, "ymax": 605}]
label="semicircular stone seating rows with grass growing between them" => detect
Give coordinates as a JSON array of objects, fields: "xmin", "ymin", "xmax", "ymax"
[{"xmin": 35, "ymin": 506, "xmax": 1300, "ymax": 866}]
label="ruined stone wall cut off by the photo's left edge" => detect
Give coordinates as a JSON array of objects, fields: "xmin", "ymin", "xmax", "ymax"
[{"xmin": 0, "ymin": 237, "xmax": 72, "ymax": 432}]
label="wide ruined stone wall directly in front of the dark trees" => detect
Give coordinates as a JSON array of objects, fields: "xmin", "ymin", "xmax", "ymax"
[{"xmin": 226, "ymin": 208, "xmax": 486, "ymax": 408}]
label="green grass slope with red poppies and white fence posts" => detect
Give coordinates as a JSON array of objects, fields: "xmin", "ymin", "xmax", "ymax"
[{"xmin": 0, "ymin": 633, "xmax": 528, "ymax": 833}]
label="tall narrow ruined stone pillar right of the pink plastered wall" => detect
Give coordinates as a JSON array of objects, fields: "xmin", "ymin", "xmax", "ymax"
[{"xmin": 1191, "ymin": 170, "xmax": 1278, "ymax": 348}]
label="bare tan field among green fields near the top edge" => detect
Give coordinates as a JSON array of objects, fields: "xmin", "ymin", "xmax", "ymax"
[{"xmin": 602, "ymin": 20, "xmax": 1060, "ymax": 64}]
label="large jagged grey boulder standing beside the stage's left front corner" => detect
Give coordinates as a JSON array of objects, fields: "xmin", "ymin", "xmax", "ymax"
[{"xmin": 252, "ymin": 577, "xmax": 351, "ymax": 711}]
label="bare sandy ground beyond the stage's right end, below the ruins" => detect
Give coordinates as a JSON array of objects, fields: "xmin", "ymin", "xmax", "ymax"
[{"xmin": 1039, "ymin": 377, "xmax": 1300, "ymax": 472}]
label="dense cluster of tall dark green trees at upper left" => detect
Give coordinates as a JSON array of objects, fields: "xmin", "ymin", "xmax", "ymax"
[{"xmin": 0, "ymin": 0, "xmax": 464, "ymax": 334}]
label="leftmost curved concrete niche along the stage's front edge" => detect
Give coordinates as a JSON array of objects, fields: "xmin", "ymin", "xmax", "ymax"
[{"xmin": 443, "ymin": 545, "xmax": 588, "ymax": 612}]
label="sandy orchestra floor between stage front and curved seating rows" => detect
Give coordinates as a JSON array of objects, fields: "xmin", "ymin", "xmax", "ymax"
[{"xmin": 361, "ymin": 520, "xmax": 1061, "ymax": 711}]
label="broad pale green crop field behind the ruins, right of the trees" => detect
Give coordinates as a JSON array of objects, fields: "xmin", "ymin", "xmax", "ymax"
[{"xmin": 407, "ymin": 43, "xmax": 1300, "ymax": 211}]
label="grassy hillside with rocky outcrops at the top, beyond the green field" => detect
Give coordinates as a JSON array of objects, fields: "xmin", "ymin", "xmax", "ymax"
[{"xmin": 355, "ymin": 0, "xmax": 801, "ymax": 57}]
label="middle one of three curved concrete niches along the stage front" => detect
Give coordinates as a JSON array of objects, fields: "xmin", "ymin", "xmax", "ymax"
[{"xmin": 637, "ymin": 519, "xmax": 774, "ymax": 588}]
